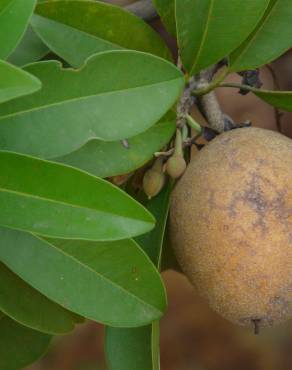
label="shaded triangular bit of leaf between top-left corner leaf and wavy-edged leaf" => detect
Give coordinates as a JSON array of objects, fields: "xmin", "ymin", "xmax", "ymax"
[{"xmin": 8, "ymin": 26, "xmax": 49, "ymax": 66}]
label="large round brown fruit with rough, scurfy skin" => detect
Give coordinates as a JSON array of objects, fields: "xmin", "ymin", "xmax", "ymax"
[{"xmin": 170, "ymin": 128, "xmax": 292, "ymax": 326}]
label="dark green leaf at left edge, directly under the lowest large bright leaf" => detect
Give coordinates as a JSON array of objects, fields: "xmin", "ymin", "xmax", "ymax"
[{"xmin": 0, "ymin": 262, "xmax": 75, "ymax": 335}]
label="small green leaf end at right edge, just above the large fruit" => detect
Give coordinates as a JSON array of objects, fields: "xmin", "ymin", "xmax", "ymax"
[{"xmin": 252, "ymin": 89, "xmax": 292, "ymax": 112}]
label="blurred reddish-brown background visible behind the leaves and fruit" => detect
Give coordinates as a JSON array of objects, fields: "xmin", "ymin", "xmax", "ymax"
[{"xmin": 25, "ymin": 0, "xmax": 292, "ymax": 370}]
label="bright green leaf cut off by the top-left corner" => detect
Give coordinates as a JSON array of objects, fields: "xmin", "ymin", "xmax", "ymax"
[{"xmin": 0, "ymin": 0, "xmax": 36, "ymax": 59}]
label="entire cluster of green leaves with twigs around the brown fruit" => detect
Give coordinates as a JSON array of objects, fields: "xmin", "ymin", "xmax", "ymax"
[{"xmin": 0, "ymin": 0, "xmax": 292, "ymax": 370}]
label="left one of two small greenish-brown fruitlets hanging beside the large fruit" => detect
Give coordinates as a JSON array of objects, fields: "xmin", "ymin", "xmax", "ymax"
[{"xmin": 143, "ymin": 158, "xmax": 165, "ymax": 199}]
